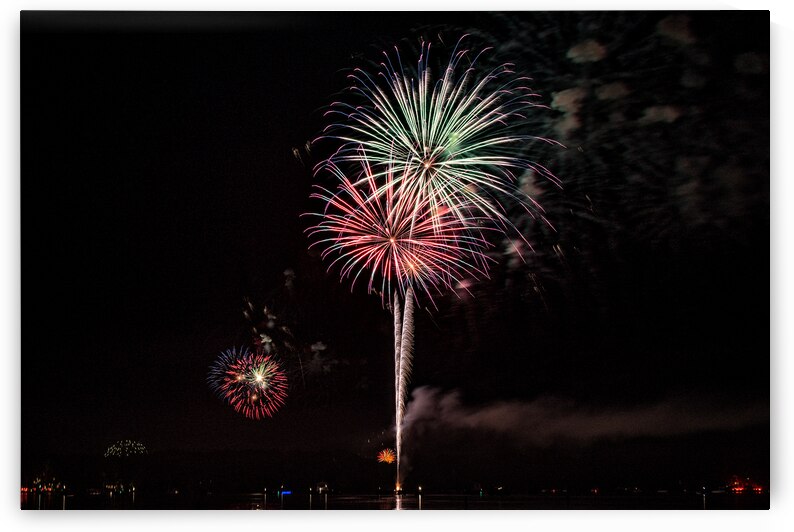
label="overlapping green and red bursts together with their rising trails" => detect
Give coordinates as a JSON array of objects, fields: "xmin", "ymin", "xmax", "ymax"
[{"xmin": 309, "ymin": 39, "xmax": 559, "ymax": 490}]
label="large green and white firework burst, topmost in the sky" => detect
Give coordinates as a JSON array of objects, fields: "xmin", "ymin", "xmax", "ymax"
[{"xmin": 316, "ymin": 39, "xmax": 557, "ymax": 236}]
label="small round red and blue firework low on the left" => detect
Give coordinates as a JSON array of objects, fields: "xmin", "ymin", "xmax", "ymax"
[{"xmin": 207, "ymin": 348, "xmax": 287, "ymax": 419}]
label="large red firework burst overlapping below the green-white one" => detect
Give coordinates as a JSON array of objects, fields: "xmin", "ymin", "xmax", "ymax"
[{"xmin": 309, "ymin": 152, "xmax": 490, "ymax": 303}]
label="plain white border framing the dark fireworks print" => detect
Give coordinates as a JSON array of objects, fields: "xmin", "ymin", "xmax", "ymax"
[{"xmin": 0, "ymin": 0, "xmax": 794, "ymax": 532}]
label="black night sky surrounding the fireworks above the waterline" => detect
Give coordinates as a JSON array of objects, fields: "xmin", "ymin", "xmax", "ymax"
[{"xmin": 21, "ymin": 12, "xmax": 770, "ymax": 494}]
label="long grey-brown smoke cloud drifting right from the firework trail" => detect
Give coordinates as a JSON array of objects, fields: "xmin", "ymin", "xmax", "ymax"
[{"xmin": 404, "ymin": 387, "xmax": 769, "ymax": 447}]
